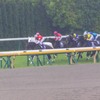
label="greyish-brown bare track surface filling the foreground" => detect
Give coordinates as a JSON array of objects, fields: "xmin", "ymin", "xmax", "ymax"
[{"xmin": 0, "ymin": 64, "xmax": 100, "ymax": 100}]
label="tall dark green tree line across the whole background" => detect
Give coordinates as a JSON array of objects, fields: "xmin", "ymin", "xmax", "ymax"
[{"xmin": 0, "ymin": 0, "xmax": 100, "ymax": 48}]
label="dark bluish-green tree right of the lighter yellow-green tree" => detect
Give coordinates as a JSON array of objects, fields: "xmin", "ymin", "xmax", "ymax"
[{"xmin": 76, "ymin": 0, "xmax": 100, "ymax": 32}]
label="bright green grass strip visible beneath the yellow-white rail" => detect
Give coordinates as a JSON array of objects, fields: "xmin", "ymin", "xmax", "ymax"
[{"xmin": 0, "ymin": 53, "xmax": 98, "ymax": 68}]
